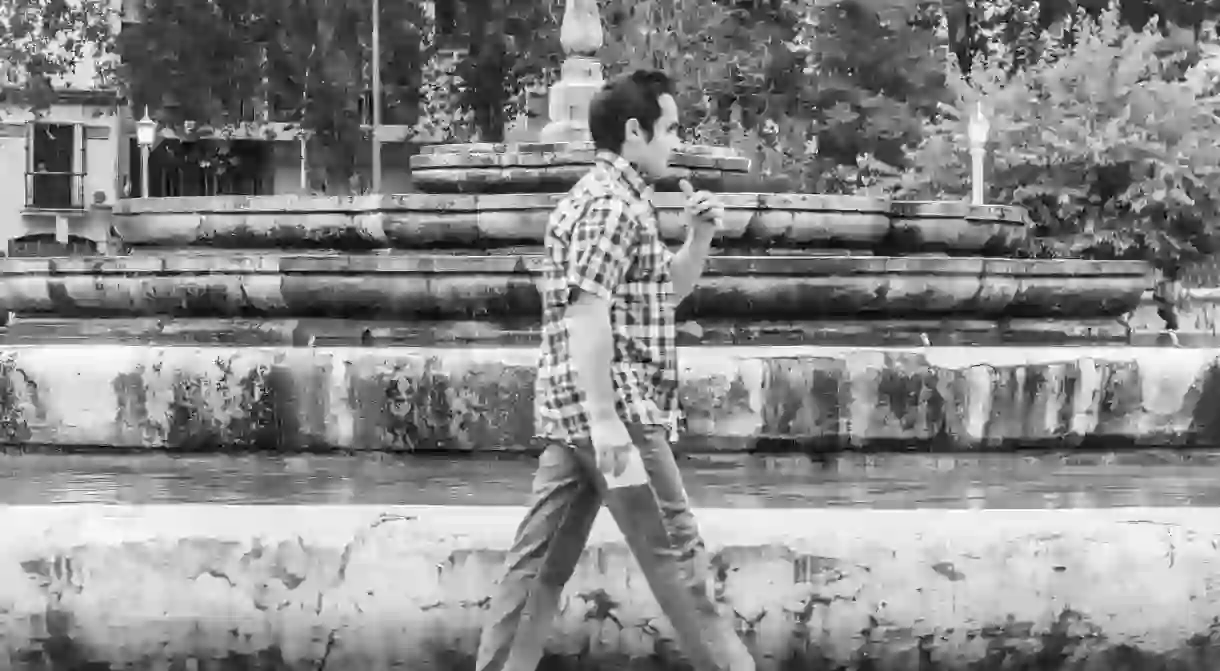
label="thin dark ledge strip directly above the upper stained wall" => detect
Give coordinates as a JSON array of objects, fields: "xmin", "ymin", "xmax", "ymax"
[{"xmin": 0, "ymin": 315, "xmax": 1141, "ymax": 346}]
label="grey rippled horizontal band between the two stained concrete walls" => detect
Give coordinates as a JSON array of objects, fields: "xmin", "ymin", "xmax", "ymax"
[{"xmin": 0, "ymin": 450, "xmax": 1220, "ymax": 509}]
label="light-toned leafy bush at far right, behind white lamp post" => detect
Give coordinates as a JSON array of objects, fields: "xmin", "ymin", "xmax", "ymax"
[{"xmin": 889, "ymin": 11, "xmax": 1220, "ymax": 270}]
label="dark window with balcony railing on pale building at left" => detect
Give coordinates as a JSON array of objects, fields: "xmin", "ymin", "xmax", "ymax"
[{"xmin": 26, "ymin": 123, "xmax": 85, "ymax": 210}]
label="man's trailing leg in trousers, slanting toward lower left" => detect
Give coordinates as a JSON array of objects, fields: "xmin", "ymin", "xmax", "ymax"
[{"xmin": 475, "ymin": 442, "xmax": 601, "ymax": 671}]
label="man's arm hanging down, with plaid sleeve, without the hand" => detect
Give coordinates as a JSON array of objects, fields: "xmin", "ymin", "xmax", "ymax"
[{"xmin": 566, "ymin": 198, "xmax": 639, "ymax": 422}]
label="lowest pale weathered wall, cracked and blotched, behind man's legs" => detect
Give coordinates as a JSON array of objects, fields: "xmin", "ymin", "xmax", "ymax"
[{"xmin": 0, "ymin": 505, "xmax": 1220, "ymax": 671}]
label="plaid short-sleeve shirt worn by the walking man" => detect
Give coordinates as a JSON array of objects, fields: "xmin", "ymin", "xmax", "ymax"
[{"xmin": 534, "ymin": 151, "xmax": 677, "ymax": 439}]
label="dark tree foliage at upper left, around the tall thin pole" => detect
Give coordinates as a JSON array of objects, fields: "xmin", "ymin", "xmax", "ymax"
[{"xmin": 118, "ymin": 0, "xmax": 431, "ymax": 192}]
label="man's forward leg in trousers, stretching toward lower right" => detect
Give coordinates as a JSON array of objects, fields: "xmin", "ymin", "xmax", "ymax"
[{"xmin": 578, "ymin": 426, "xmax": 754, "ymax": 671}]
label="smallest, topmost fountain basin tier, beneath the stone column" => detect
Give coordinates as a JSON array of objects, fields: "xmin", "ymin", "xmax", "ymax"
[{"xmin": 411, "ymin": 142, "xmax": 750, "ymax": 194}]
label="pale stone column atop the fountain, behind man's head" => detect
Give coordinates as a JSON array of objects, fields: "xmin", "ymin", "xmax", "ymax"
[{"xmin": 539, "ymin": 0, "xmax": 604, "ymax": 142}]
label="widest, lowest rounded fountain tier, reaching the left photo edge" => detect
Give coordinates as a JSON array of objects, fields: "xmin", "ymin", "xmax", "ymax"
[{"xmin": 0, "ymin": 251, "xmax": 1149, "ymax": 321}]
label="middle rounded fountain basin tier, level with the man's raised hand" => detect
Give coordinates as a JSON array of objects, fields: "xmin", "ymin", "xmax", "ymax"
[{"xmin": 115, "ymin": 193, "xmax": 1027, "ymax": 256}]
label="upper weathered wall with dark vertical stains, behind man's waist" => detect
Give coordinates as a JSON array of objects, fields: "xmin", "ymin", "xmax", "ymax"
[{"xmin": 0, "ymin": 345, "xmax": 1220, "ymax": 451}]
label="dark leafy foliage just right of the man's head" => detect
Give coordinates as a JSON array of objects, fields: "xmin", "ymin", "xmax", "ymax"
[{"xmin": 604, "ymin": 0, "xmax": 947, "ymax": 192}]
